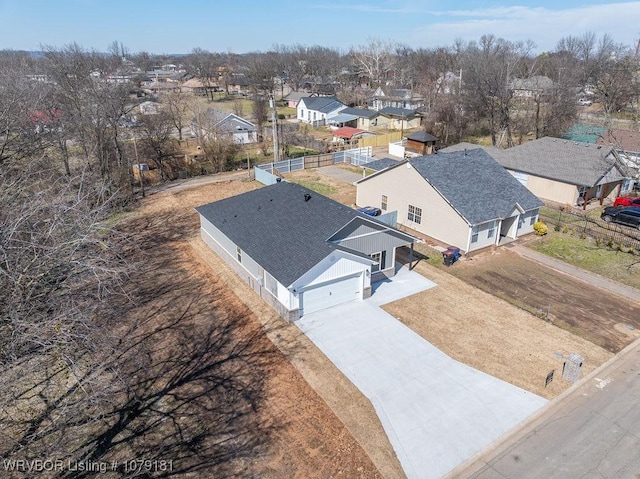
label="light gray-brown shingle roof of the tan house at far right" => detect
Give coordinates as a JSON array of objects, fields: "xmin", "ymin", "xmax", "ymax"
[{"xmin": 489, "ymin": 137, "xmax": 623, "ymax": 186}]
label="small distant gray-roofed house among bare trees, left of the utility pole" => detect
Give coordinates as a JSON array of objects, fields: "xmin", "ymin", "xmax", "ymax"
[{"xmin": 191, "ymin": 108, "xmax": 258, "ymax": 144}]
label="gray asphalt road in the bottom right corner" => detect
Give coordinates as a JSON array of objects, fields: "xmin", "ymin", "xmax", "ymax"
[{"xmin": 448, "ymin": 340, "xmax": 640, "ymax": 479}]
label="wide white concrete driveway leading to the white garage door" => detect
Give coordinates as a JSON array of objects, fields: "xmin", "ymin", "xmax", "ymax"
[{"xmin": 296, "ymin": 268, "xmax": 547, "ymax": 479}]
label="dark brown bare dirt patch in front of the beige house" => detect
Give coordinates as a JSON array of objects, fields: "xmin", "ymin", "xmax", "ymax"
[{"xmin": 451, "ymin": 248, "xmax": 640, "ymax": 353}]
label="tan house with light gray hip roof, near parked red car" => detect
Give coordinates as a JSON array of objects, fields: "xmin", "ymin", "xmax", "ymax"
[{"xmin": 476, "ymin": 137, "xmax": 633, "ymax": 207}]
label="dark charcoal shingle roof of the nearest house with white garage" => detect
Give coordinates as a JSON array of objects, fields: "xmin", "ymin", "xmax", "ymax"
[{"xmin": 196, "ymin": 182, "xmax": 403, "ymax": 286}]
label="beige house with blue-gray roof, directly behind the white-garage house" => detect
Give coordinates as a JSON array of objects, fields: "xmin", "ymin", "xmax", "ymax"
[{"xmin": 356, "ymin": 148, "xmax": 543, "ymax": 252}]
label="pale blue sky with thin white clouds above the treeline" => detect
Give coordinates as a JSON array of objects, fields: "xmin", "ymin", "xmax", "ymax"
[{"xmin": 0, "ymin": 0, "xmax": 640, "ymax": 54}]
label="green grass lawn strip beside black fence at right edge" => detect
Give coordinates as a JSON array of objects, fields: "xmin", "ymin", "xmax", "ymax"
[{"xmin": 527, "ymin": 232, "xmax": 640, "ymax": 289}]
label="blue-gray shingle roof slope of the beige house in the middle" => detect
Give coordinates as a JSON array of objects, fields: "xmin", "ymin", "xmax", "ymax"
[{"xmin": 408, "ymin": 148, "xmax": 543, "ymax": 224}]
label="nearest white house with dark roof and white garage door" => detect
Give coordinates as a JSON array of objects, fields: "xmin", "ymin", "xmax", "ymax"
[{"xmin": 196, "ymin": 182, "xmax": 419, "ymax": 321}]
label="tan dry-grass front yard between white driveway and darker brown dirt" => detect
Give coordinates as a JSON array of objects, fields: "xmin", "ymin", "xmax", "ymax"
[{"xmin": 383, "ymin": 249, "xmax": 612, "ymax": 398}]
